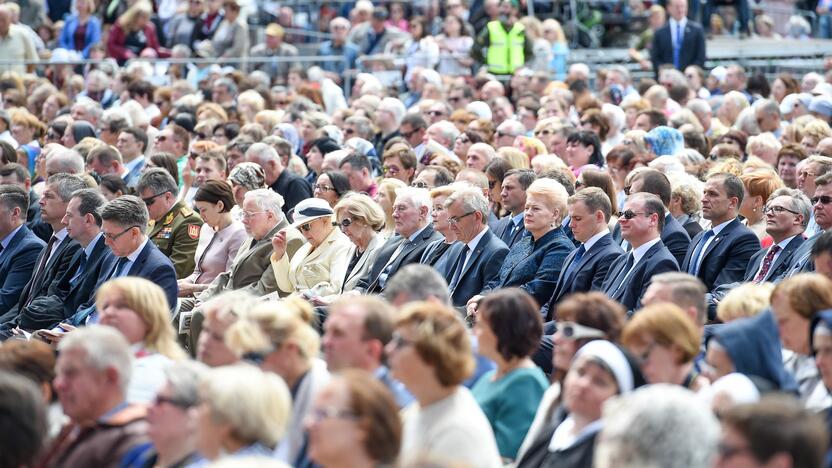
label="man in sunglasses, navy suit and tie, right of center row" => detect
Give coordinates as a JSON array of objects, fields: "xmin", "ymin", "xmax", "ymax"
[{"xmin": 601, "ymin": 192, "xmax": 679, "ymax": 315}]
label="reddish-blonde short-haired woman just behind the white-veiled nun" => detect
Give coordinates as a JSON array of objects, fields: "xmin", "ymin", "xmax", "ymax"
[{"xmin": 621, "ymin": 303, "xmax": 709, "ymax": 392}]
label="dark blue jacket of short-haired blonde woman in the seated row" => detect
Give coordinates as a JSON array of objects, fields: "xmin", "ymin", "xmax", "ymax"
[{"xmin": 482, "ymin": 227, "xmax": 575, "ymax": 304}]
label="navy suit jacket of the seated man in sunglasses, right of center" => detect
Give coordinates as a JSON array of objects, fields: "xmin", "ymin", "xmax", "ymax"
[{"xmin": 601, "ymin": 240, "xmax": 679, "ymax": 315}]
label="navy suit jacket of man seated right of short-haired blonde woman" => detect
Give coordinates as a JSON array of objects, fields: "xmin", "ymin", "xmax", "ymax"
[{"xmin": 541, "ymin": 234, "xmax": 624, "ymax": 321}]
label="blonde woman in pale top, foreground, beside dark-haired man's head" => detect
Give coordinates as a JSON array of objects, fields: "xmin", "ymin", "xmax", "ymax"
[{"xmin": 225, "ymin": 301, "xmax": 330, "ymax": 464}]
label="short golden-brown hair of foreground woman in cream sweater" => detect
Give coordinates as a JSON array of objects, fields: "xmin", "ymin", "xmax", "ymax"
[{"xmin": 396, "ymin": 302, "xmax": 474, "ymax": 387}]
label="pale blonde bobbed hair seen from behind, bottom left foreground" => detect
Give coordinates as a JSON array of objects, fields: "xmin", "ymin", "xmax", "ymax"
[{"xmin": 200, "ymin": 364, "xmax": 292, "ymax": 448}]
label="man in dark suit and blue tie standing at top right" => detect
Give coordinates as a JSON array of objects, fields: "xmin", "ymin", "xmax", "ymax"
[{"xmin": 650, "ymin": 0, "xmax": 707, "ymax": 77}]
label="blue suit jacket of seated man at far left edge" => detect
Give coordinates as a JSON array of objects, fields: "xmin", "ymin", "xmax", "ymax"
[{"xmin": 0, "ymin": 226, "xmax": 46, "ymax": 315}]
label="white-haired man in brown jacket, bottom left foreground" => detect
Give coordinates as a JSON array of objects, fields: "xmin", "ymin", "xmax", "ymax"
[{"xmin": 48, "ymin": 325, "xmax": 149, "ymax": 467}]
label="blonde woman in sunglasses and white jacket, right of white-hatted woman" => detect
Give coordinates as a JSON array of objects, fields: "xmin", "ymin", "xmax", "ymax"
[{"xmin": 312, "ymin": 193, "xmax": 386, "ymax": 306}]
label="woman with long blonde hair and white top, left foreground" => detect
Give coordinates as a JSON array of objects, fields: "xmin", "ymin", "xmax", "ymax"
[{"xmin": 95, "ymin": 276, "xmax": 185, "ymax": 403}]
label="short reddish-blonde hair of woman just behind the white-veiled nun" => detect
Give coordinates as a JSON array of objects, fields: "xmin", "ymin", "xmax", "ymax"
[{"xmin": 621, "ymin": 303, "xmax": 702, "ymax": 364}]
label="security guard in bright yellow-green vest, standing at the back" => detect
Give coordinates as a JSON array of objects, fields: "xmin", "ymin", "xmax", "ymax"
[{"xmin": 471, "ymin": 0, "xmax": 534, "ymax": 75}]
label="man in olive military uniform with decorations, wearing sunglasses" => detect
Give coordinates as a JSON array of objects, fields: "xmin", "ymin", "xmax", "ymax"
[{"xmin": 136, "ymin": 168, "xmax": 202, "ymax": 279}]
